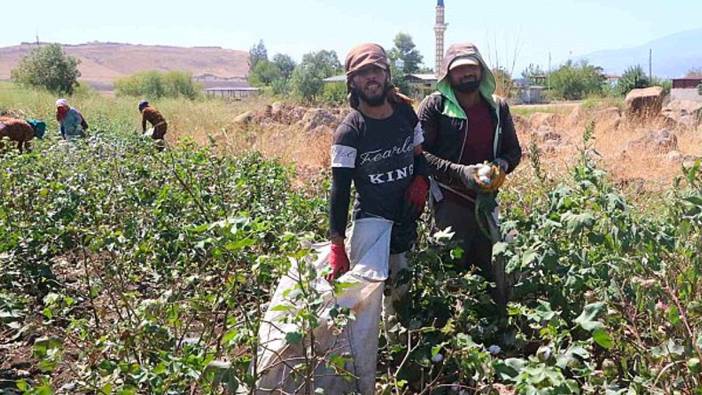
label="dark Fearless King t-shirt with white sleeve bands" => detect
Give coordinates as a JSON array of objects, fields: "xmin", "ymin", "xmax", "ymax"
[{"xmin": 331, "ymin": 104, "xmax": 423, "ymax": 227}]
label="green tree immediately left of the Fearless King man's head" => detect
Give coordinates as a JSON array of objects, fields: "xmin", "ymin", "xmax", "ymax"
[{"xmin": 291, "ymin": 50, "xmax": 343, "ymax": 101}]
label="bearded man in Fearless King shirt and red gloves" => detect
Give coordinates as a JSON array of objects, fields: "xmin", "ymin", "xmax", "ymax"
[{"xmin": 327, "ymin": 44, "xmax": 429, "ymax": 315}]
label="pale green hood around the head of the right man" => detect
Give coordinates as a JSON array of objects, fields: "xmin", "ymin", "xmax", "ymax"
[{"xmin": 436, "ymin": 43, "xmax": 497, "ymax": 119}]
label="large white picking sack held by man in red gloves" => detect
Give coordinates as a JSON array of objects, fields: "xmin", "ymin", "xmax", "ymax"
[{"xmin": 256, "ymin": 218, "xmax": 393, "ymax": 394}]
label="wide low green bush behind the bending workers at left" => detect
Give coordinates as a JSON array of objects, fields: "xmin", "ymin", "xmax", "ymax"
[{"xmin": 115, "ymin": 71, "xmax": 202, "ymax": 99}]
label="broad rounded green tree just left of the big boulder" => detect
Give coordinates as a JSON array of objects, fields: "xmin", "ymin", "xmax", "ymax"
[{"xmin": 550, "ymin": 60, "xmax": 606, "ymax": 100}]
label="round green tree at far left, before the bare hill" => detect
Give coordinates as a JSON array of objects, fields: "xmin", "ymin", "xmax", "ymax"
[{"xmin": 11, "ymin": 44, "xmax": 80, "ymax": 95}]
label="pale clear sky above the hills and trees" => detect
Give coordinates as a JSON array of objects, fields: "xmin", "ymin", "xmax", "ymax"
[{"xmin": 5, "ymin": 0, "xmax": 702, "ymax": 74}]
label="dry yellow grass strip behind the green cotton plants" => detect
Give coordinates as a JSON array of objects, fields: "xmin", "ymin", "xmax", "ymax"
[{"xmin": 0, "ymin": 83, "xmax": 702, "ymax": 193}]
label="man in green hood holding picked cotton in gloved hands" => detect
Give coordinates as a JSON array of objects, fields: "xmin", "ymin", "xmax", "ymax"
[{"xmin": 418, "ymin": 43, "xmax": 522, "ymax": 307}]
